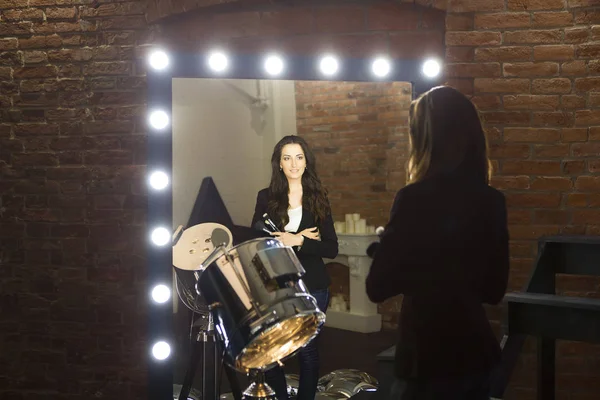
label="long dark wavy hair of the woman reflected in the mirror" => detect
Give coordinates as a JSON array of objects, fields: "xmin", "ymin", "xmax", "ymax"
[{"xmin": 267, "ymin": 135, "xmax": 331, "ymax": 229}]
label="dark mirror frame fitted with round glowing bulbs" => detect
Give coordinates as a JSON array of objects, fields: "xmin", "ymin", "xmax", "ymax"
[{"xmin": 146, "ymin": 48, "xmax": 443, "ymax": 400}]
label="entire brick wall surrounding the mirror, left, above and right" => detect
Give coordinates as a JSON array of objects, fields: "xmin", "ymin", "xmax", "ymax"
[{"xmin": 0, "ymin": 0, "xmax": 600, "ymax": 400}]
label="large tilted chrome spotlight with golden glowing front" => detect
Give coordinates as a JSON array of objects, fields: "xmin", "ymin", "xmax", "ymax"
[{"xmin": 196, "ymin": 238, "xmax": 325, "ymax": 372}]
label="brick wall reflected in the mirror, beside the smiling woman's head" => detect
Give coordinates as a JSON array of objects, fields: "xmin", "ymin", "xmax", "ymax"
[{"xmin": 296, "ymin": 81, "xmax": 412, "ymax": 226}]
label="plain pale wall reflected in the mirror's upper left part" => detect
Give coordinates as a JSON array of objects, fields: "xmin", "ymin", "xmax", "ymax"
[{"xmin": 173, "ymin": 79, "xmax": 296, "ymax": 228}]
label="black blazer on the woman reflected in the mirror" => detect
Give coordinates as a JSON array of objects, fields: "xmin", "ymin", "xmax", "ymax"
[{"xmin": 252, "ymin": 188, "xmax": 338, "ymax": 292}]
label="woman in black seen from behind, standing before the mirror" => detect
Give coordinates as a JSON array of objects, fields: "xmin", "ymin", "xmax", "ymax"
[{"xmin": 366, "ymin": 87, "xmax": 509, "ymax": 400}]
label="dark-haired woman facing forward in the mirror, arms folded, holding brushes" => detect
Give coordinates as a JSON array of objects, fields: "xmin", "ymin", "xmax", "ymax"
[{"xmin": 252, "ymin": 135, "xmax": 338, "ymax": 400}]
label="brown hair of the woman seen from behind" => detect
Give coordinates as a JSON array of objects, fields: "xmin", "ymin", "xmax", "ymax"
[{"xmin": 406, "ymin": 86, "xmax": 492, "ymax": 184}]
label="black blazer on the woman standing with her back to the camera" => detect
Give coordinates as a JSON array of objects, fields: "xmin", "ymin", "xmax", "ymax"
[{"xmin": 366, "ymin": 176, "xmax": 509, "ymax": 379}]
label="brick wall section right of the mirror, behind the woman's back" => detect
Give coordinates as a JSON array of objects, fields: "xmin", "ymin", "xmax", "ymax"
[{"xmin": 446, "ymin": 0, "xmax": 600, "ymax": 399}]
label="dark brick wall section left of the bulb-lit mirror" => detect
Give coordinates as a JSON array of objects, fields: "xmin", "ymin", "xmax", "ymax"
[{"xmin": 0, "ymin": 0, "xmax": 148, "ymax": 400}]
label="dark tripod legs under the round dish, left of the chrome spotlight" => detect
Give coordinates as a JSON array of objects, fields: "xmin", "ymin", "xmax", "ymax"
[{"xmin": 178, "ymin": 313, "xmax": 242, "ymax": 400}]
